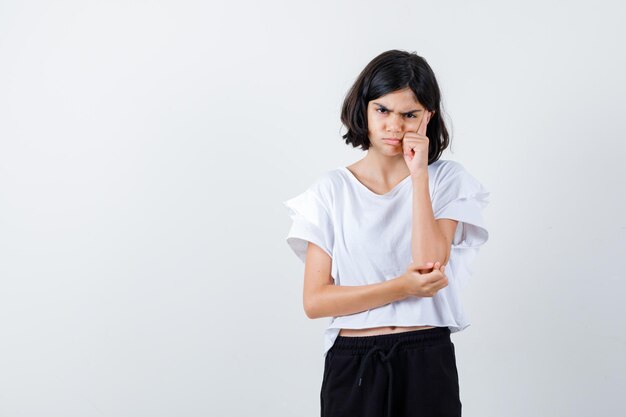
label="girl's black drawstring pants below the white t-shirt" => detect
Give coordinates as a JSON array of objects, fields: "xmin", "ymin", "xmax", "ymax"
[{"xmin": 320, "ymin": 327, "xmax": 461, "ymax": 417}]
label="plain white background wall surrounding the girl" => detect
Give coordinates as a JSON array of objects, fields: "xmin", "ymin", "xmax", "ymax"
[{"xmin": 0, "ymin": 0, "xmax": 626, "ymax": 417}]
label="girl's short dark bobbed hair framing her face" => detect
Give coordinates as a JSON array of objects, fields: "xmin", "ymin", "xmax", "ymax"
[{"xmin": 341, "ymin": 49, "xmax": 450, "ymax": 165}]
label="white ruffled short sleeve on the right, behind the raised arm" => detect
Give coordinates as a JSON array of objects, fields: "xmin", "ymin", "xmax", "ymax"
[{"xmin": 432, "ymin": 161, "xmax": 489, "ymax": 288}]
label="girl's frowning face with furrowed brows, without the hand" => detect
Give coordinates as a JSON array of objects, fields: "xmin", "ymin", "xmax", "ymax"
[{"xmin": 367, "ymin": 88, "xmax": 426, "ymax": 155}]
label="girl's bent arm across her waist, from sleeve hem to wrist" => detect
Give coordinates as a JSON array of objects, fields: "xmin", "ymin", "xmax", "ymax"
[{"xmin": 303, "ymin": 243, "xmax": 409, "ymax": 319}]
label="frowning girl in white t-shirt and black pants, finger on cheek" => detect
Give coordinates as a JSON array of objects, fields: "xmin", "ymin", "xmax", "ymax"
[{"xmin": 283, "ymin": 50, "xmax": 489, "ymax": 417}]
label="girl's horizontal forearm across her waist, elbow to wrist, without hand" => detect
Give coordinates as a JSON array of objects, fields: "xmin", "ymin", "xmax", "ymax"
[{"xmin": 307, "ymin": 277, "xmax": 408, "ymax": 319}]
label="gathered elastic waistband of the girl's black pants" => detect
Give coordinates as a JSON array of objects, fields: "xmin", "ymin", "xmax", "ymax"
[{"xmin": 331, "ymin": 327, "xmax": 450, "ymax": 353}]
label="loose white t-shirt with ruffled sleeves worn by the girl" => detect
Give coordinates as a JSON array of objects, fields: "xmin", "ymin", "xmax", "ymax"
[{"xmin": 283, "ymin": 159, "xmax": 489, "ymax": 356}]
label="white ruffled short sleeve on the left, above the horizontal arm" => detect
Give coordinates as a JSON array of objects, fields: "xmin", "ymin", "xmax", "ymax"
[{"xmin": 283, "ymin": 187, "xmax": 334, "ymax": 262}]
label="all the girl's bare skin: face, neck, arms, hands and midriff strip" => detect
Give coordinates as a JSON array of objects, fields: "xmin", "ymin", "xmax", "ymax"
[{"xmin": 303, "ymin": 89, "xmax": 457, "ymax": 336}]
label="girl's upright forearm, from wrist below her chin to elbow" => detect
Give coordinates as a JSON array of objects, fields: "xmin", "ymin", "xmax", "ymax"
[{"xmin": 411, "ymin": 171, "xmax": 447, "ymax": 265}]
